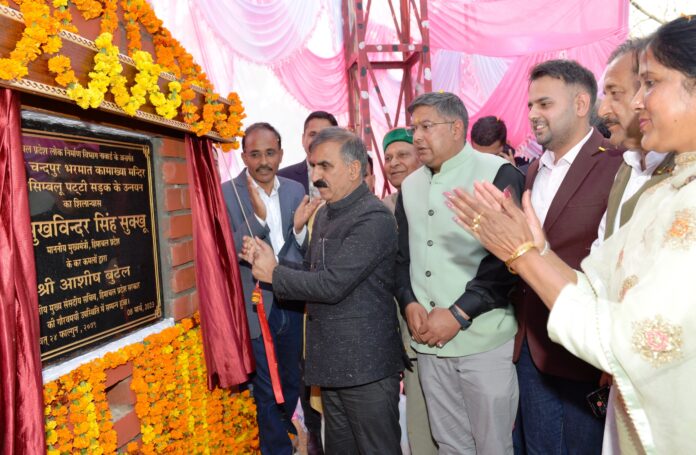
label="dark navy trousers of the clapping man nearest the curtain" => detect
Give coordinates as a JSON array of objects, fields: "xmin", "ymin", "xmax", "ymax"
[{"xmin": 251, "ymin": 305, "xmax": 302, "ymax": 455}]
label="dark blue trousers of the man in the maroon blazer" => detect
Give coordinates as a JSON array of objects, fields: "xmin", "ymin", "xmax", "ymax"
[{"xmin": 513, "ymin": 340, "xmax": 604, "ymax": 455}]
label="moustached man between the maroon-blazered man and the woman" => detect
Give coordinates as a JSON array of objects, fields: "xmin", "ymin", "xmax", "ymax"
[{"xmin": 592, "ymin": 40, "xmax": 674, "ymax": 455}]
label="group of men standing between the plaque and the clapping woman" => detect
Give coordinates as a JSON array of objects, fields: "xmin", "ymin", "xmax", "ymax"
[{"xmin": 223, "ymin": 35, "xmax": 656, "ymax": 455}]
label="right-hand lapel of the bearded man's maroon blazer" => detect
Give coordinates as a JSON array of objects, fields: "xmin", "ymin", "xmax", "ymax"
[{"xmin": 544, "ymin": 130, "xmax": 603, "ymax": 232}]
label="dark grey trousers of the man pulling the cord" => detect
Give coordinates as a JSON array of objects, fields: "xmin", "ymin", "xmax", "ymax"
[{"xmin": 321, "ymin": 374, "xmax": 401, "ymax": 455}]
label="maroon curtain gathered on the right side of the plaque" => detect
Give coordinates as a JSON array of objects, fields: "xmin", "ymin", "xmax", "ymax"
[{"xmin": 186, "ymin": 135, "xmax": 254, "ymax": 390}]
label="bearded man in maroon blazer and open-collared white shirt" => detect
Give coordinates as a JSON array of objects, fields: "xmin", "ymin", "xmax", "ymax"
[{"xmin": 514, "ymin": 60, "xmax": 621, "ymax": 454}]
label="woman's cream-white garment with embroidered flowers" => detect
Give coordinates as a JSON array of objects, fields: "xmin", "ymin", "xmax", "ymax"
[{"xmin": 548, "ymin": 153, "xmax": 696, "ymax": 454}]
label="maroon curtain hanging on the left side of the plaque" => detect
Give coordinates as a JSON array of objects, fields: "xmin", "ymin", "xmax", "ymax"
[{"xmin": 0, "ymin": 88, "xmax": 46, "ymax": 454}]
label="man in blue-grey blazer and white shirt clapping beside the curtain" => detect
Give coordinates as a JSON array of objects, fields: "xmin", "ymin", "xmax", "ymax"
[{"xmin": 222, "ymin": 123, "xmax": 319, "ymax": 455}]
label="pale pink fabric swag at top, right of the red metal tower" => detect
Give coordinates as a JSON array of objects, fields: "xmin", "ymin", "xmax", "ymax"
[{"xmin": 428, "ymin": 0, "xmax": 628, "ymax": 57}]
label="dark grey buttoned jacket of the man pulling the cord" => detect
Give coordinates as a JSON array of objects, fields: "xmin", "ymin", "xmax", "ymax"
[{"xmin": 273, "ymin": 184, "xmax": 403, "ymax": 387}]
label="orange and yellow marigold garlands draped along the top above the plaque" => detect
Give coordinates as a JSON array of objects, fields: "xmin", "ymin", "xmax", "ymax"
[{"xmin": 0, "ymin": 0, "xmax": 245, "ymax": 146}]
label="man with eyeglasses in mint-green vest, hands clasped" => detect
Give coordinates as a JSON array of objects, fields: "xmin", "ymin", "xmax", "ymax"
[{"xmin": 395, "ymin": 93, "xmax": 524, "ymax": 455}]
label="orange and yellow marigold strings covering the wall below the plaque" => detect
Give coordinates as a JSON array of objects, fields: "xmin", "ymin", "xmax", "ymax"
[{"xmin": 44, "ymin": 319, "xmax": 258, "ymax": 455}]
